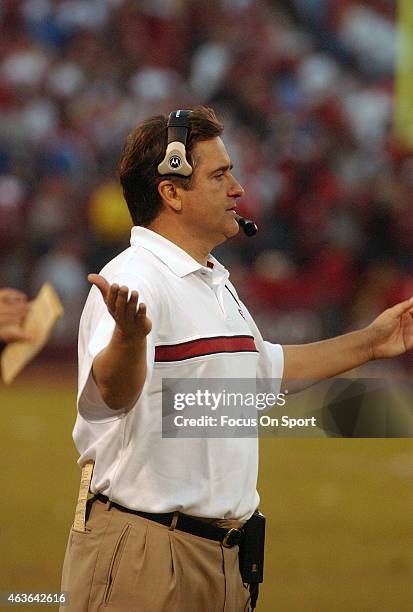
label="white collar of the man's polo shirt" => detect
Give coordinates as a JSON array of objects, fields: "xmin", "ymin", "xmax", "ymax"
[{"xmin": 130, "ymin": 226, "xmax": 227, "ymax": 278}]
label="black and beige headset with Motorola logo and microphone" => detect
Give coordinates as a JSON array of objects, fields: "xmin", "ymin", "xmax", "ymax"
[{"xmin": 158, "ymin": 110, "xmax": 258, "ymax": 236}]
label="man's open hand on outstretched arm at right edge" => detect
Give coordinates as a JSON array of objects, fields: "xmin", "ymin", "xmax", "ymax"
[{"xmin": 367, "ymin": 298, "xmax": 413, "ymax": 359}]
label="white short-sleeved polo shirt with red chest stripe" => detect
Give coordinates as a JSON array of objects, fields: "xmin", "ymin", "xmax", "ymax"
[{"xmin": 73, "ymin": 227, "xmax": 283, "ymax": 520}]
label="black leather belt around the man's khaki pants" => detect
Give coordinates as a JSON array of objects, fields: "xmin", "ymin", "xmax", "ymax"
[{"xmin": 90, "ymin": 493, "xmax": 244, "ymax": 548}]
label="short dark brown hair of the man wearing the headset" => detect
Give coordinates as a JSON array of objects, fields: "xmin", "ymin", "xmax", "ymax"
[{"xmin": 119, "ymin": 106, "xmax": 224, "ymax": 225}]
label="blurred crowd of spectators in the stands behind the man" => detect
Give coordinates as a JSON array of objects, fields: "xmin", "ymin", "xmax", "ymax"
[{"xmin": 0, "ymin": 0, "xmax": 413, "ymax": 367}]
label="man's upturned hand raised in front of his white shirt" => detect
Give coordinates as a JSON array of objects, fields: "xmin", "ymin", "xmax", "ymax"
[{"xmin": 87, "ymin": 274, "xmax": 152, "ymax": 339}]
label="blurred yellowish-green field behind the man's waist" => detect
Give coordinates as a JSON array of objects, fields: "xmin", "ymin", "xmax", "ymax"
[{"xmin": 0, "ymin": 369, "xmax": 413, "ymax": 612}]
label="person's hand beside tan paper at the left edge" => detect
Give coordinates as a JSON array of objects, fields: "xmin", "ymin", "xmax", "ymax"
[{"xmin": 0, "ymin": 287, "xmax": 29, "ymax": 350}]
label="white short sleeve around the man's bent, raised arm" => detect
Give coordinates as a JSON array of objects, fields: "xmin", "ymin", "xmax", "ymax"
[{"xmin": 77, "ymin": 273, "xmax": 159, "ymax": 422}]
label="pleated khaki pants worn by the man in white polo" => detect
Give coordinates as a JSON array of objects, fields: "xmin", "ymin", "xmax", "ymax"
[{"xmin": 61, "ymin": 500, "xmax": 249, "ymax": 612}]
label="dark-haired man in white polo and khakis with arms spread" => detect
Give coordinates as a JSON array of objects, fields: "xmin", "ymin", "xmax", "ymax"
[{"xmin": 62, "ymin": 107, "xmax": 413, "ymax": 612}]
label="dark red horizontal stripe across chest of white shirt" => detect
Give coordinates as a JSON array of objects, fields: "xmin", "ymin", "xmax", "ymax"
[{"xmin": 155, "ymin": 336, "xmax": 258, "ymax": 362}]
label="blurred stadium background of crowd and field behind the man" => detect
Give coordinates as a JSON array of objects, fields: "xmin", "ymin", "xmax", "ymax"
[{"xmin": 0, "ymin": 0, "xmax": 413, "ymax": 612}]
